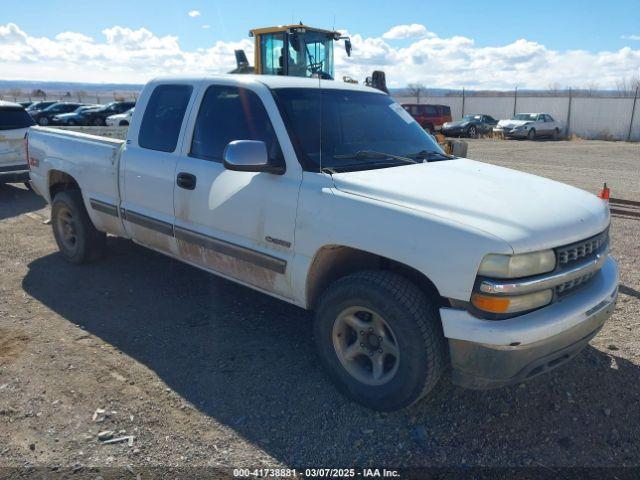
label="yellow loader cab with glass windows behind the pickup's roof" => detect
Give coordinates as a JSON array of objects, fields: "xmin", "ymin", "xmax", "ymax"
[{"xmin": 229, "ymin": 22, "xmax": 389, "ymax": 93}]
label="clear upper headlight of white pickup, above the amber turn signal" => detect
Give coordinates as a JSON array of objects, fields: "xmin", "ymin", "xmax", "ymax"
[{"xmin": 478, "ymin": 250, "xmax": 556, "ymax": 278}]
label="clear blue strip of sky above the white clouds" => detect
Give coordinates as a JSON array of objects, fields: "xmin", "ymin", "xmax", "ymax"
[{"xmin": 8, "ymin": 0, "xmax": 640, "ymax": 51}]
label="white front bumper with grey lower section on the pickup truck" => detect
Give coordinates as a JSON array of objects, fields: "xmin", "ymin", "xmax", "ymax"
[{"xmin": 440, "ymin": 257, "xmax": 618, "ymax": 389}]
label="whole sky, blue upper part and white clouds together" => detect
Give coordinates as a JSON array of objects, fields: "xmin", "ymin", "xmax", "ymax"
[{"xmin": 0, "ymin": 0, "xmax": 640, "ymax": 88}]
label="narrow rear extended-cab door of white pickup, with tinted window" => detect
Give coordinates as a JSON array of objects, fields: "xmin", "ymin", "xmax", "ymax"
[{"xmin": 120, "ymin": 82, "xmax": 197, "ymax": 255}]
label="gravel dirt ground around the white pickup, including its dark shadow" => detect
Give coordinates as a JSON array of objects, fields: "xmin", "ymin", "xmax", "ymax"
[{"xmin": 0, "ymin": 141, "xmax": 640, "ymax": 472}]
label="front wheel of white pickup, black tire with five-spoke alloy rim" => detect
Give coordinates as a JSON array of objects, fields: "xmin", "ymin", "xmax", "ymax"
[{"xmin": 314, "ymin": 271, "xmax": 446, "ymax": 411}]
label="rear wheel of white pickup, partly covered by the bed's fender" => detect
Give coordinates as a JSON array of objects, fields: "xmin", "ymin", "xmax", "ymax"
[{"xmin": 51, "ymin": 190, "xmax": 106, "ymax": 265}]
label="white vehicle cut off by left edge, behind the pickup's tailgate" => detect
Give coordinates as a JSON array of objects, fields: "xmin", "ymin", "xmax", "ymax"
[{"xmin": 0, "ymin": 100, "xmax": 36, "ymax": 184}]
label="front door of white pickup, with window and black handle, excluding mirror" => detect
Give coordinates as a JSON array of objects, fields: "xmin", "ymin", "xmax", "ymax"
[{"xmin": 174, "ymin": 80, "xmax": 302, "ymax": 298}]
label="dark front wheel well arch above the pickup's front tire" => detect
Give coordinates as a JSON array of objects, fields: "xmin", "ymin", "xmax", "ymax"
[{"xmin": 306, "ymin": 245, "xmax": 448, "ymax": 310}]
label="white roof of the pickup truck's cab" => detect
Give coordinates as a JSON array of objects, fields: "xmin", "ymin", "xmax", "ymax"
[{"xmin": 150, "ymin": 74, "xmax": 384, "ymax": 94}]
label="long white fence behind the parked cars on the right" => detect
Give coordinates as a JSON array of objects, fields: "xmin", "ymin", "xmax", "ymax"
[{"xmin": 396, "ymin": 94, "xmax": 640, "ymax": 141}]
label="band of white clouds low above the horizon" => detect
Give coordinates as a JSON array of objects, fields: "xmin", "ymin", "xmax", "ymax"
[{"xmin": 0, "ymin": 23, "xmax": 640, "ymax": 89}]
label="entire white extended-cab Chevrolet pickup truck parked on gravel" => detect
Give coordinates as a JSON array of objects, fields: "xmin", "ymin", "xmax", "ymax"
[{"xmin": 27, "ymin": 75, "xmax": 618, "ymax": 410}]
